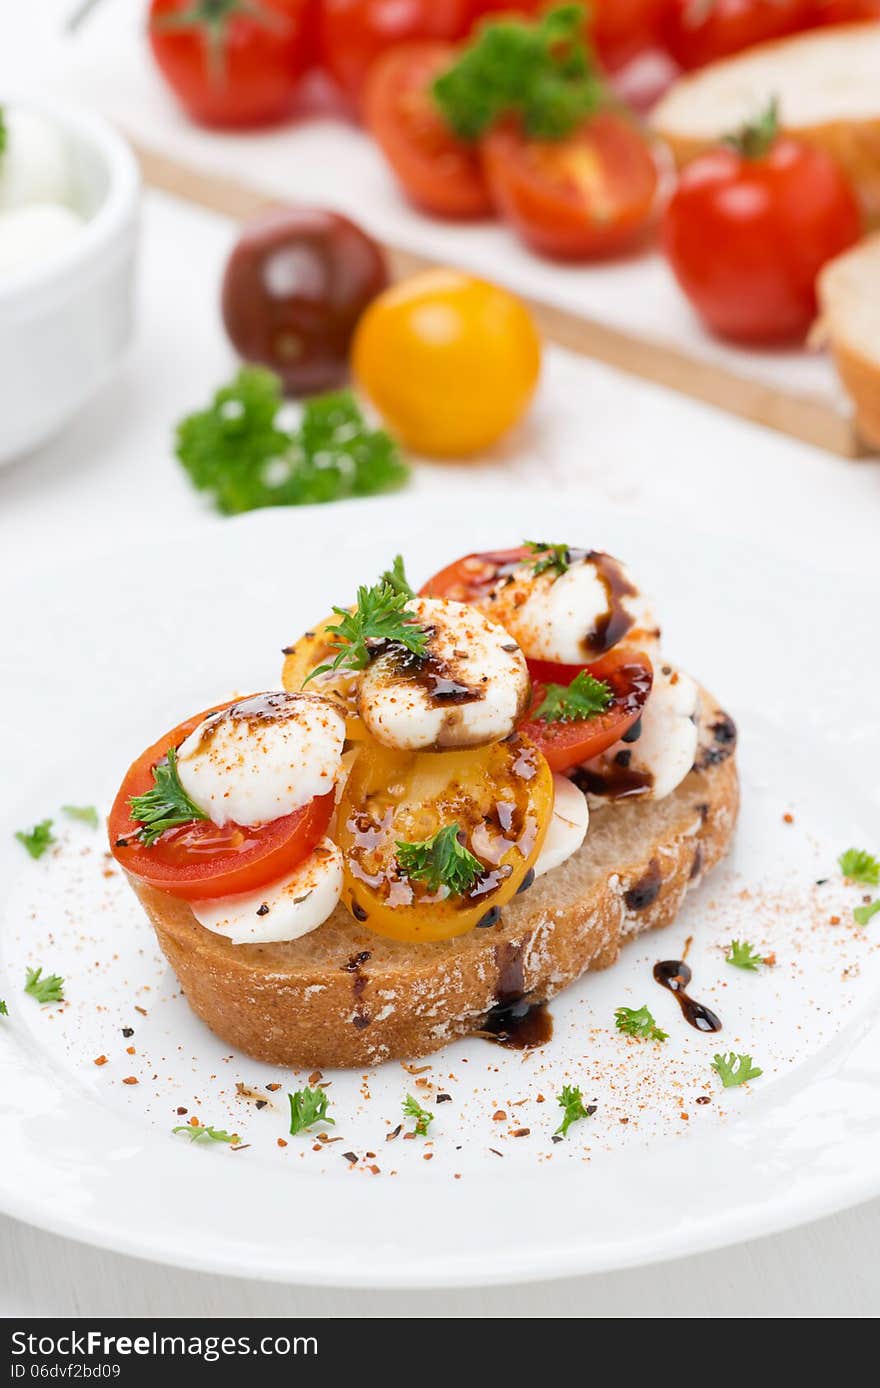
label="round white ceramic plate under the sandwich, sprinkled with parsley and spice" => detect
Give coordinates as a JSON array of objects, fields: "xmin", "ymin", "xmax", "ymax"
[{"xmin": 0, "ymin": 487, "xmax": 880, "ymax": 1287}]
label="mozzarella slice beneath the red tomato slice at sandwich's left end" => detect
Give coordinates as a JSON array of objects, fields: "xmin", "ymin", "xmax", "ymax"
[{"xmin": 190, "ymin": 838, "xmax": 343, "ymax": 945}]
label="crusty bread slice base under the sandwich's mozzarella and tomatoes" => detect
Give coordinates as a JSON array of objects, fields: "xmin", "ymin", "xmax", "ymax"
[{"xmin": 130, "ymin": 694, "xmax": 738, "ymax": 1069}]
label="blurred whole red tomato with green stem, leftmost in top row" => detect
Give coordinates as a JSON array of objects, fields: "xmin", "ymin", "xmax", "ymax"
[{"xmin": 149, "ymin": 0, "xmax": 315, "ymax": 128}]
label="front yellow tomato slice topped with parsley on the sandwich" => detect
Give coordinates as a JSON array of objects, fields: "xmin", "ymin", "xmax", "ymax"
[{"xmin": 336, "ymin": 733, "xmax": 552, "ymax": 940}]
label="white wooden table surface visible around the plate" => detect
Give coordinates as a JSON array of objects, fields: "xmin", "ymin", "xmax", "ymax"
[{"xmin": 0, "ymin": 10, "xmax": 880, "ymax": 1317}]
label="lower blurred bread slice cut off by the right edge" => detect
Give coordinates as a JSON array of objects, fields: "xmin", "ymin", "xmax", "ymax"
[{"xmin": 816, "ymin": 233, "xmax": 880, "ymax": 448}]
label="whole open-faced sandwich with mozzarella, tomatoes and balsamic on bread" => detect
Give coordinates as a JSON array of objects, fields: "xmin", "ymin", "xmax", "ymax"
[{"xmin": 110, "ymin": 543, "xmax": 738, "ymax": 1066}]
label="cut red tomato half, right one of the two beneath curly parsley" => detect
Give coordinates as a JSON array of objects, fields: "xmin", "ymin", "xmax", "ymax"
[{"xmin": 483, "ymin": 110, "xmax": 658, "ymax": 260}]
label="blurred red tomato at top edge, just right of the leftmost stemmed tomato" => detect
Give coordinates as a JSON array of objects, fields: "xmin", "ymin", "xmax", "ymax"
[{"xmin": 321, "ymin": 0, "xmax": 472, "ymax": 108}]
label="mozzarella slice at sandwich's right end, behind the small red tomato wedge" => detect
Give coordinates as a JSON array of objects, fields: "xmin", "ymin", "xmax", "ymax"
[{"xmin": 587, "ymin": 665, "xmax": 700, "ymax": 801}]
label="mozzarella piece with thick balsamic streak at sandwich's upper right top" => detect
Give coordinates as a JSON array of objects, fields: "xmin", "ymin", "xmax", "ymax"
[{"xmin": 480, "ymin": 551, "xmax": 659, "ymax": 665}]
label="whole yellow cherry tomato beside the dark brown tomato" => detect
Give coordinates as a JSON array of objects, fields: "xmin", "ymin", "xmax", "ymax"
[{"xmin": 351, "ymin": 269, "xmax": 541, "ymax": 458}]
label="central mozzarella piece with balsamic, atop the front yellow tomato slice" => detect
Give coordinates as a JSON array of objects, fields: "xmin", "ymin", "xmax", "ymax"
[{"xmin": 358, "ymin": 598, "xmax": 530, "ymax": 751}]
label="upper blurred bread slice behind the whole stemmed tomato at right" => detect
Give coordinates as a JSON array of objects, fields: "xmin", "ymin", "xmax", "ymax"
[{"xmin": 651, "ymin": 21, "xmax": 880, "ymax": 223}]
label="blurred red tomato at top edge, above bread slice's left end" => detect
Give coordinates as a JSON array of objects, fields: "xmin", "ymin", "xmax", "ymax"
[{"xmin": 661, "ymin": 0, "xmax": 811, "ymax": 71}]
